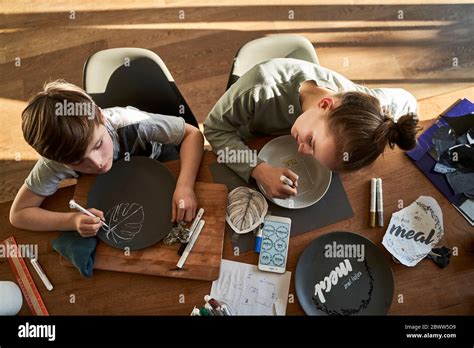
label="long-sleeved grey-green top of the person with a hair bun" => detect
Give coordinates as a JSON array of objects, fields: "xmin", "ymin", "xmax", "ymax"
[{"xmin": 204, "ymin": 58, "xmax": 417, "ymax": 181}]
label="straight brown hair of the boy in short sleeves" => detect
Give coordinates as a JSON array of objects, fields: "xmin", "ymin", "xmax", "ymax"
[{"xmin": 21, "ymin": 80, "xmax": 102, "ymax": 164}]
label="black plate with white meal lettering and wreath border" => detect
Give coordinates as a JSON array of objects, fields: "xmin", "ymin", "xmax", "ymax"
[{"xmin": 295, "ymin": 232, "xmax": 394, "ymax": 315}]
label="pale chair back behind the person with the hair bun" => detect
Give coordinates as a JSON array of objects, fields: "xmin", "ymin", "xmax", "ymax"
[{"xmin": 226, "ymin": 34, "xmax": 319, "ymax": 89}]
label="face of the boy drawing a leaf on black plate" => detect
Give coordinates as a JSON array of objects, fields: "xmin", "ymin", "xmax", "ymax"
[{"xmin": 68, "ymin": 113, "xmax": 114, "ymax": 174}]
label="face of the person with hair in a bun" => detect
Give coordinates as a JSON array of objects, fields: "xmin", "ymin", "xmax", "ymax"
[{"xmin": 291, "ymin": 97, "xmax": 339, "ymax": 169}]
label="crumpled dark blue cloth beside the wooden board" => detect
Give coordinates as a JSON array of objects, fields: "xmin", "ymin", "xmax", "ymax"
[{"xmin": 51, "ymin": 231, "xmax": 98, "ymax": 278}]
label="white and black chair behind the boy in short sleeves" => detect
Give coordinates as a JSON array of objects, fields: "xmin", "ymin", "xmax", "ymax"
[{"xmin": 83, "ymin": 47, "xmax": 198, "ymax": 127}]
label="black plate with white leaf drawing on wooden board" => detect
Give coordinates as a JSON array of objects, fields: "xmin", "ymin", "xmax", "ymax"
[{"xmin": 87, "ymin": 157, "xmax": 176, "ymax": 250}]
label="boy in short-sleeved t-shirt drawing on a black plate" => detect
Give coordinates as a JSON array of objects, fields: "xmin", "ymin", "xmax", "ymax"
[{"xmin": 10, "ymin": 80, "xmax": 204, "ymax": 237}]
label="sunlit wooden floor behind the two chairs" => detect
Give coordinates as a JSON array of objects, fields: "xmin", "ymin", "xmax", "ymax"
[{"xmin": 0, "ymin": 0, "xmax": 474, "ymax": 202}]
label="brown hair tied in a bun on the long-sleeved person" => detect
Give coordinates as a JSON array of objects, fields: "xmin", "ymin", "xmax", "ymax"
[{"xmin": 328, "ymin": 92, "xmax": 421, "ymax": 171}]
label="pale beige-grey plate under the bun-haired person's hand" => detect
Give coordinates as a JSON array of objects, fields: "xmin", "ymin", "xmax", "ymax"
[{"xmin": 257, "ymin": 135, "xmax": 332, "ymax": 209}]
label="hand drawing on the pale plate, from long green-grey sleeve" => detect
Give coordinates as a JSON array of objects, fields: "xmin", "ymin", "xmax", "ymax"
[{"xmin": 252, "ymin": 163, "xmax": 298, "ymax": 198}]
